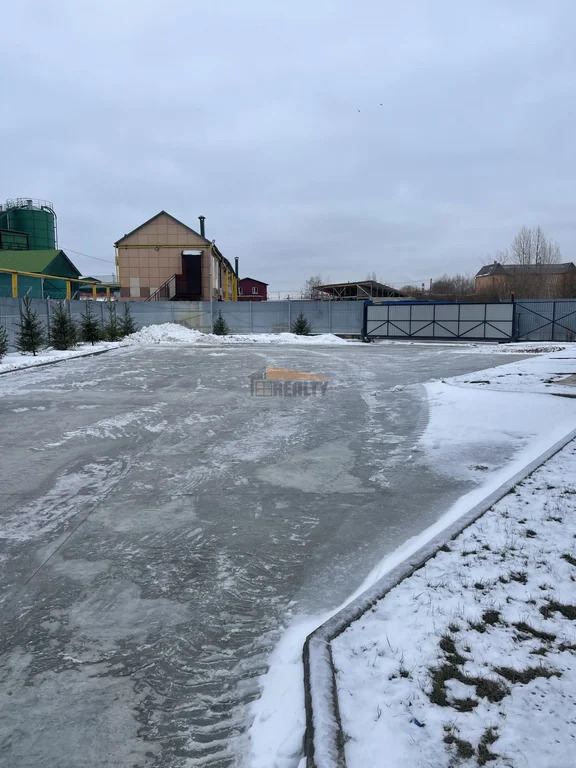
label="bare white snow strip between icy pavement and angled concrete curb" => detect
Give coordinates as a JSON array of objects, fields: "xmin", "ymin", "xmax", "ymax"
[{"xmin": 250, "ymin": 344, "xmax": 576, "ymax": 768}]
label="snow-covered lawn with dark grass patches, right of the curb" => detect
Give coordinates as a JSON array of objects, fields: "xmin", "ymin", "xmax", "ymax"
[{"xmin": 332, "ymin": 443, "xmax": 576, "ymax": 768}]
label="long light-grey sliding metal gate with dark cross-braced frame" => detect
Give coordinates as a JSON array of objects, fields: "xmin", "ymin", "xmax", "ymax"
[{"xmin": 363, "ymin": 302, "xmax": 514, "ymax": 341}]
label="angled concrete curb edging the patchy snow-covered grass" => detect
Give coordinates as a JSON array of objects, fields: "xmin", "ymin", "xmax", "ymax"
[{"xmin": 303, "ymin": 429, "xmax": 576, "ymax": 768}]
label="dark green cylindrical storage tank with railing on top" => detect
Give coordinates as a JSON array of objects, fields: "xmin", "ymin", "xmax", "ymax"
[{"xmin": 0, "ymin": 197, "xmax": 58, "ymax": 251}]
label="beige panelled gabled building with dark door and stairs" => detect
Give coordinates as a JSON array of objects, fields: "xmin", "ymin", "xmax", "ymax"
[{"xmin": 114, "ymin": 211, "xmax": 238, "ymax": 301}]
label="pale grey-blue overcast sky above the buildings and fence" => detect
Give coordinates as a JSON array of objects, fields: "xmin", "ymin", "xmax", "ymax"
[{"xmin": 0, "ymin": 0, "xmax": 576, "ymax": 292}]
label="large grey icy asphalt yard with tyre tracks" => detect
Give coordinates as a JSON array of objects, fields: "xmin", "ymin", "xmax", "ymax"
[{"xmin": 0, "ymin": 345, "xmax": 532, "ymax": 768}]
